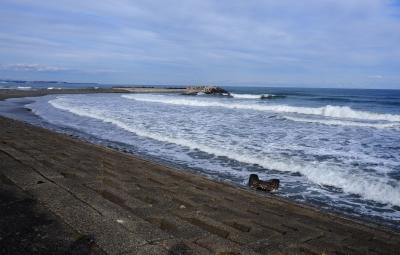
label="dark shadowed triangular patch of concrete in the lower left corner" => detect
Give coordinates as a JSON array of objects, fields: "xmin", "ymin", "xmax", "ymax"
[{"xmin": 0, "ymin": 164, "xmax": 103, "ymax": 255}]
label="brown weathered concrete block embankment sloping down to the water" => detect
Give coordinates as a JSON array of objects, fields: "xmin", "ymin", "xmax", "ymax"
[{"xmin": 0, "ymin": 118, "xmax": 400, "ymax": 254}]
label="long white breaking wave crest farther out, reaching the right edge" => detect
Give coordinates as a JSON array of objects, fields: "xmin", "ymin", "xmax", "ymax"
[{"xmin": 122, "ymin": 95, "xmax": 400, "ymax": 122}]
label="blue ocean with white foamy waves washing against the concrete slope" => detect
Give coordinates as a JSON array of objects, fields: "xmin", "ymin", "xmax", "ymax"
[{"xmin": 0, "ymin": 87, "xmax": 400, "ymax": 228}]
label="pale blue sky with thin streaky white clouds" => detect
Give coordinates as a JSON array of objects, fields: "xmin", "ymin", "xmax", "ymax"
[{"xmin": 0, "ymin": 0, "xmax": 400, "ymax": 89}]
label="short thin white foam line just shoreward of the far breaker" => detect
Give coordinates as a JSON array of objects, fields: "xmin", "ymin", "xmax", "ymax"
[{"xmin": 283, "ymin": 116, "xmax": 400, "ymax": 128}]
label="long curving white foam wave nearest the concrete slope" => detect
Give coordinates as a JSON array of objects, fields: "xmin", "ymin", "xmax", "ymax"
[{"xmin": 49, "ymin": 98, "xmax": 400, "ymax": 206}]
